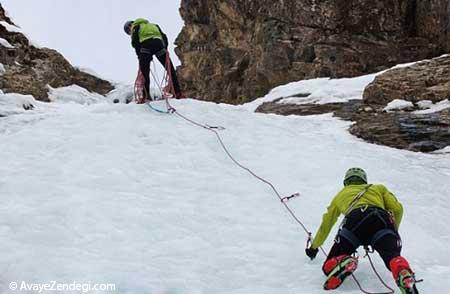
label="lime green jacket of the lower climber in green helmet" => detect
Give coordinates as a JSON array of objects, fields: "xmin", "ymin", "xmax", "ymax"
[{"xmin": 311, "ymin": 185, "xmax": 403, "ymax": 248}]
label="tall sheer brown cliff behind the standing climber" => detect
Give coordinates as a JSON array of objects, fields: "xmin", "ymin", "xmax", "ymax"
[{"xmin": 176, "ymin": 0, "xmax": 450, "ymax": 103}]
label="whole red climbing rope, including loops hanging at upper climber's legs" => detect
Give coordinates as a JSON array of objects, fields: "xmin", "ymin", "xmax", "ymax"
[{"xmin": 133, "ymin": 53, "xmax": 395, "ymax": 294}]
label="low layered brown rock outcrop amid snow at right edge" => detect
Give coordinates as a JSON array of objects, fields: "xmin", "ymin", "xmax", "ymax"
[{"xmin": 257, "ymin": 56, "xmax": 450, "ymax": 152}]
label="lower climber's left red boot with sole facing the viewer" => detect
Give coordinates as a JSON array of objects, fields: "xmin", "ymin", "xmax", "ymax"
[{"xmin": 323, "ymin": 255, "xmax": 358, "ymax": 290}]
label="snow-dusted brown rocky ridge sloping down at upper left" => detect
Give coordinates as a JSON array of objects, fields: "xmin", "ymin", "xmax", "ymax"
[{"xmin": 0, "ymin": 4, "xmax": 113, "ymax": 101}]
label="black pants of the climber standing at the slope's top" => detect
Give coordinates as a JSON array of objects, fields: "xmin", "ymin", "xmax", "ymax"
[{"xmin": 138, "ymin": 39, "xmax": 181, "ymax": 98}]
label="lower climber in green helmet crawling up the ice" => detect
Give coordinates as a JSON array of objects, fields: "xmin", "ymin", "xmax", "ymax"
[{"xmin": 306, "ymin": 168, "xmax": 418, "ymax": 294}]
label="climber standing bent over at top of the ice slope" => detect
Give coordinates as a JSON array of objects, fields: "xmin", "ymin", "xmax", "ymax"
[{"xmin": 124, "ymin": 18, "xmax": 183, "ymax": 99}]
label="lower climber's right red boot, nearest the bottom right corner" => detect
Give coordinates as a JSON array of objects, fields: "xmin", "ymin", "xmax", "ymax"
[{"xmin": 389, "ymin": 256, "xmax": 419, "ymax": 294}]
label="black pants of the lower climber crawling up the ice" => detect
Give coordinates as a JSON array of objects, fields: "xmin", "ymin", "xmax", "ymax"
[{"xmin": 327, "ymin": 206, "xmax": 402, "ymax": 270}]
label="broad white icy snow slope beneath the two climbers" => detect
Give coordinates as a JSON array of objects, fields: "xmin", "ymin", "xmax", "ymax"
[{"xmin": 0, "ymin": 89, "xmax": 450, "ymax": 294}]
